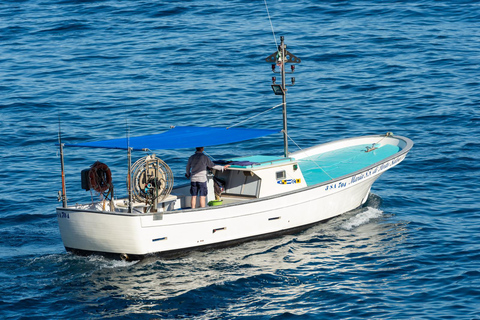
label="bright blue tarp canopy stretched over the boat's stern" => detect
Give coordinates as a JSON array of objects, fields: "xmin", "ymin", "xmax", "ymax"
[{"xmin": 65, "ymin": 126, "xmax": 280, "ymax": 150}]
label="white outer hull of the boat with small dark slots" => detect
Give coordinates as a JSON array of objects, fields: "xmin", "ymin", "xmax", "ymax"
[{"xmin": 57, "ymin": 136, "xmax": 411, "ymax": 259}]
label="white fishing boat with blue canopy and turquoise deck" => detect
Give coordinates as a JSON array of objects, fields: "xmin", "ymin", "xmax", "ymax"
[{"xmin": 56, "ymin": 37, "xmax": 413, "ymax": 260}]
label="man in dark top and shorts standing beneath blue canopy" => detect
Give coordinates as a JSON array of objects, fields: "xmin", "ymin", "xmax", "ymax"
[{"xmin": 185, "ymin": 147, "xmax": 230, "ymax": 209}]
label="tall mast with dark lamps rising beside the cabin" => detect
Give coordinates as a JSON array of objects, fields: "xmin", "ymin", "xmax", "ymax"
[{"xmin": 265, "ymin": 36, "xmax": 301, "ymax": 157}]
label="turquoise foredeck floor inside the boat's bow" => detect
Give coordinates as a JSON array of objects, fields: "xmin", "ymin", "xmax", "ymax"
[{"xmin": 298, "ymin": 144, "xmax": 400, "ymax": 186}]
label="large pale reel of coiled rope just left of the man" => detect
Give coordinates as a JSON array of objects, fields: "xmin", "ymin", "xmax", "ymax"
[{"xmin": 131, "ymin": 154, "xmax": 173, "ymax": 212}]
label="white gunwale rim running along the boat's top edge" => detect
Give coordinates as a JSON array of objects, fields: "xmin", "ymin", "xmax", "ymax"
[{"xmin": 56, "ymin": 135, "xmax": 414, "ymax": 217}]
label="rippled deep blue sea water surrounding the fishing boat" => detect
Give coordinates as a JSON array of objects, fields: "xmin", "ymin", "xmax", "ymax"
[{"xmin": 0, "ymin": 0, "xmax": 480, "ymax": 319}]
